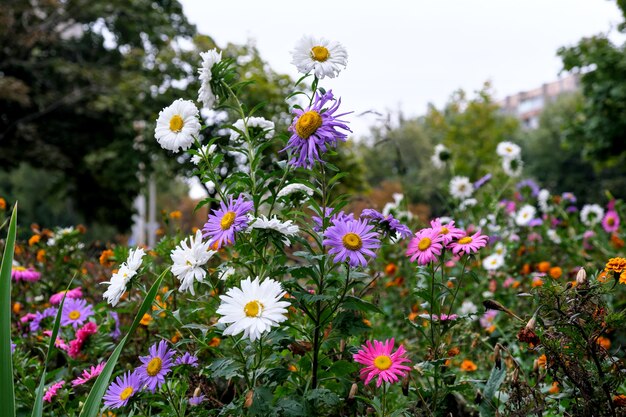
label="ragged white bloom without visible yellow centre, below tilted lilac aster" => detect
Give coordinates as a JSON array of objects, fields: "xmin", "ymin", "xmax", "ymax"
[{"xmin": 170, "ymin": 230, "xmax": 217, "ymax": 295}]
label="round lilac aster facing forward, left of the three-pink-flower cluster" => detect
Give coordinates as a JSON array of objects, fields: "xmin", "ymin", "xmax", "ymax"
[{"xmin": 323, "ymin": 219, "xmax": 380, "ymax": 267}]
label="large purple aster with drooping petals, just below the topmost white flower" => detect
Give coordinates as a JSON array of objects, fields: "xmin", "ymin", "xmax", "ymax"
[{"xmin": 282, "ymin": 90, "xmax": 352, "ymax": 168}]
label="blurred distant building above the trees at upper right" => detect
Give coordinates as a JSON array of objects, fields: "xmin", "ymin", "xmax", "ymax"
[{"xmin": 498, "ymin": 74, "xmax": 580, "ymax": 129}]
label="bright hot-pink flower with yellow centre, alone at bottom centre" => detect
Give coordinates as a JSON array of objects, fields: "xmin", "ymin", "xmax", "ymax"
[{"xmin": 354, "ymin": 338, "xmax": 411, "ymax": 387}]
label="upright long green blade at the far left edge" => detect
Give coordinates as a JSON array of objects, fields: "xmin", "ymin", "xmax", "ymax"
[{"xmin": 0, "ymin": 203, "xmax": 17, "ymax": 417}]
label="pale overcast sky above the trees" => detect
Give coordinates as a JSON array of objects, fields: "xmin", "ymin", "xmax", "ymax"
[{"xmin": 181, "ymin": 0, "xmax": 621, "ymax": 136}]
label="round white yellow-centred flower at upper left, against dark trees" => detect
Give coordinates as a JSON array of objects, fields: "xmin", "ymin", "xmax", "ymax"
[{"xmin": 154, "ymin": 98, "xmax": 200, "ymax": 152}]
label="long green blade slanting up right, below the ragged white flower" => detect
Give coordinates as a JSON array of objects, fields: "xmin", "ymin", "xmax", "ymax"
[{"xmin": 80, "ymin": 269, "xmax": 169, "ymax": 417}]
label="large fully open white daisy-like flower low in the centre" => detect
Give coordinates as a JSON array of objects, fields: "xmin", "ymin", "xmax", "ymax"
[{"xmin": 217, "ymin": 277, "xmax": 289, "ymax": 342}]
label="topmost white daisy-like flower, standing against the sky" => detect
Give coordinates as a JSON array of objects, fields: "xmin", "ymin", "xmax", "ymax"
[{"xmin": 291, "ymin": 36, "xmax": 348, "ymax": 79}]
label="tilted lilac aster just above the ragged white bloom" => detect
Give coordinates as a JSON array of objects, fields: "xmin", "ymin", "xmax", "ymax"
[{"xmin": 202, "ymin": 195, "xmax": 254, "ymax": 249}]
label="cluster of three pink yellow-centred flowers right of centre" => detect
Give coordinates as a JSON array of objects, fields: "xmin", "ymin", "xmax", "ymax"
[{"xmin": 406, "ymin": 219, "xmax": 489, "ymax": 265}]
